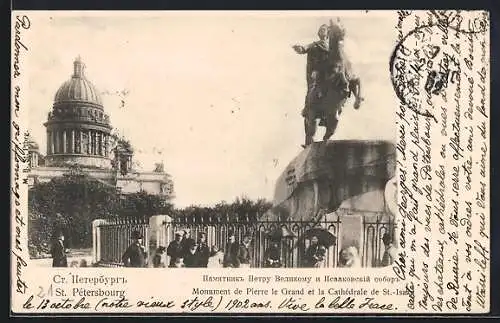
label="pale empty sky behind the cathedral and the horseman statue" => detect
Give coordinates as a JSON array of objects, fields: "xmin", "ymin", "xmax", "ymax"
[{"xmin": 25, "ymin": 11, "xmax": 397, "ymax": 207}]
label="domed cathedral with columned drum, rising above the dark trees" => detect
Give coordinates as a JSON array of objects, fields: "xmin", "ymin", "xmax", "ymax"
[{"xmin": 28, "ymin": 57, "xmax": 173, "ymax": 195}]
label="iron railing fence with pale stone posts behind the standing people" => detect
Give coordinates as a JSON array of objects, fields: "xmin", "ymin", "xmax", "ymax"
[{"xmin": 93, "ymin": 215, "xmax": 395, "ymax": 268}]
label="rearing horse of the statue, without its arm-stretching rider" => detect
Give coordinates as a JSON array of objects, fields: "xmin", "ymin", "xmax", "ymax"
[{"xmin": 303, "ymin": 20, "xmax": 363, "ymax": 146}]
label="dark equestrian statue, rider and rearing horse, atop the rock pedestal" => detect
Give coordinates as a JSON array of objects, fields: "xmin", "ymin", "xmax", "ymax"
[{"xmin": 293, "ymin": 19, "xmax": 363, "ymax": 147}]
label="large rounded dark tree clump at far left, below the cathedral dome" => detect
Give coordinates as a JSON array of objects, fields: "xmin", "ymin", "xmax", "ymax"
[{"xmin": 28, "ymin": 175, "xmax": 120, "ymax": 252}]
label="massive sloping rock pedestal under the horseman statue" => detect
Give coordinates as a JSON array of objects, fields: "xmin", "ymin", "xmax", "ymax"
[{"xmin": 273, "ymin": 140, "xmax": 396, "ymax": 221}]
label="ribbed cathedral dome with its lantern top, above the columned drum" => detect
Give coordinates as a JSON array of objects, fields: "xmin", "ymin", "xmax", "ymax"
[{"xmin": 54, "ymin": 57, "xmax": 102, "ymax": 106}]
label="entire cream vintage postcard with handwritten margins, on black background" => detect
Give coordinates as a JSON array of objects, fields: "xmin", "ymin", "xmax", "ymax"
[{"xmin": 11, "ymin": 10, "xmax": 489, "ymax": 312}]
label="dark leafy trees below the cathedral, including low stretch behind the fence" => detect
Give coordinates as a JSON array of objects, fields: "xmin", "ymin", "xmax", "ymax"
[{"xmin": 28, "ymin": 174, "xmax": 173, "ymax": 255}]
